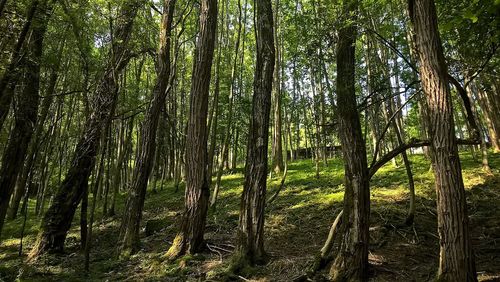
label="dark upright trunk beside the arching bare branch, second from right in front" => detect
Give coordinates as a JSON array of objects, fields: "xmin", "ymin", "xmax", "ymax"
[{"xmin": 330, "ymin": 0, "xmax": 370, "ymax": 281}]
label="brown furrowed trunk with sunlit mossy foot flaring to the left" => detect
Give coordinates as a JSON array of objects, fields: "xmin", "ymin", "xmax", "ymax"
[{"xmin": 167, "ymin": 0, "xmax": 217, "ymax": 258}]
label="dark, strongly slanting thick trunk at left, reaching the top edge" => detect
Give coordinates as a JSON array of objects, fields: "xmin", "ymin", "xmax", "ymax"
[{"xmin": 29, "ymin": 0, "xmax": 142, "ymax": 258}]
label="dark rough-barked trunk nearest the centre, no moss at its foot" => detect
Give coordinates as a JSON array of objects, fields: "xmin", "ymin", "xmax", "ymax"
[{"xmin": 234, "ymin": 0, "xmax": 275, "ymax": 271}]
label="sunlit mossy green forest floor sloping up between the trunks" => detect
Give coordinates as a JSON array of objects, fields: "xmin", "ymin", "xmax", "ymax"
[{"xmin": 0, "ymin": 153, "xmax": 500, "ymax": 281}]
